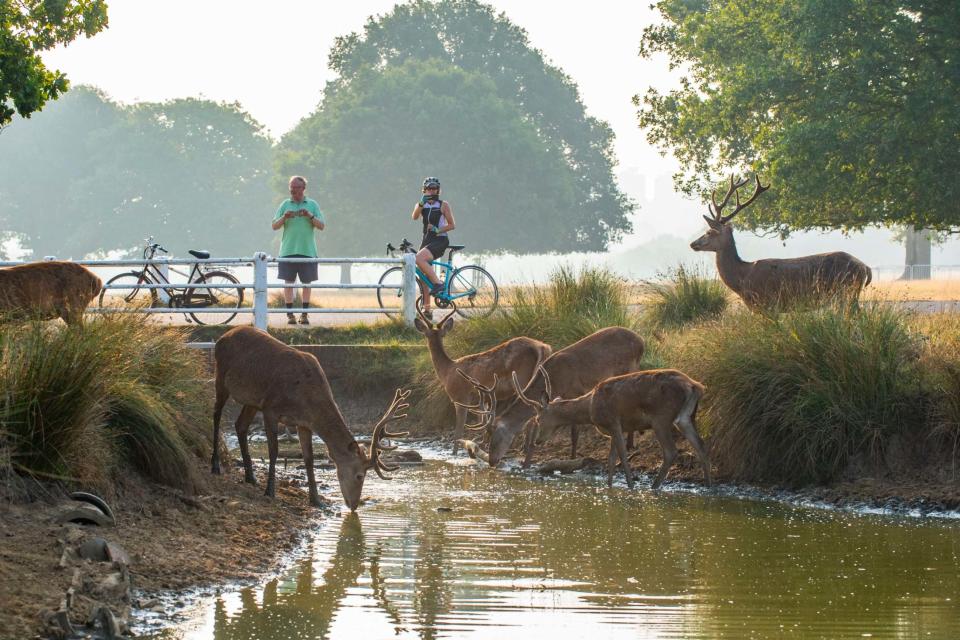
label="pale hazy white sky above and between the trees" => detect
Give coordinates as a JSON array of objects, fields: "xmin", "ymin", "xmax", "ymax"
[{"xmin": 44, "ymin": 0, "xmax": 688, "ymax": 241}]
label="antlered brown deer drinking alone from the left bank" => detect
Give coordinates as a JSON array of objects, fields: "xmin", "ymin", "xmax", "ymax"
[{"xmin": 210, "ymin": 327, "xmax": 410, "ymax": 511}]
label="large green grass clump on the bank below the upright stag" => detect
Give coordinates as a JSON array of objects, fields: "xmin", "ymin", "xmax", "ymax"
[{"xmin": 673, "ymin": 305, "xmax": 924, "ymax": 485}]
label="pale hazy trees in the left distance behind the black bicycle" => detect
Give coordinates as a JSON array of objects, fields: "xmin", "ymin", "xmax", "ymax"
[{"xmin": 0, "ymin": 87, "xmax": 276, "ymax": 258}]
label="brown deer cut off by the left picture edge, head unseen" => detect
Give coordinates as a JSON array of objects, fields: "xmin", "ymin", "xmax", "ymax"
[{"xmin": 0, "ymin": 261, "xmax": 103, "ymax": 324}]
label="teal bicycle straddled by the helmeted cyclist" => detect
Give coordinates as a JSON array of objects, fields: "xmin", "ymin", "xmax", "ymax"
[{"xmin": 377, "ymin": 238, "xmax": 500, "ymax": 318}]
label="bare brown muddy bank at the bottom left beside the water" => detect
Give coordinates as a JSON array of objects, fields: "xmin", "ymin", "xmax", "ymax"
[{"xmin": 0, "ymin": 463, "xmax": 322, "ymax": 639}]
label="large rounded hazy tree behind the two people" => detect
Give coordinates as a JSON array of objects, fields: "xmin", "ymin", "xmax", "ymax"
[{"xmin": 279, "ymin": 0, "xmax": 635, "ymax": 253}]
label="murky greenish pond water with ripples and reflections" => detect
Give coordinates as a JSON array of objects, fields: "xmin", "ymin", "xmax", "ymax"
[{"xmin": 148, "ymin": 463, "xmax": 960, "ymax": 640}]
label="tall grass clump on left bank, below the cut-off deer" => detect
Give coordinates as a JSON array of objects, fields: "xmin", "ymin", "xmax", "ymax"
[{"xmin": 0, "ymin": 315, "xmax": 209, "ymax": 491}]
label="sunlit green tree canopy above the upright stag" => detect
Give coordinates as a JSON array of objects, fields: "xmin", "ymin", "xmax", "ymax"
[{"xmin": 634, "ymin": 0, "xmax": 960, "ymax": 235}]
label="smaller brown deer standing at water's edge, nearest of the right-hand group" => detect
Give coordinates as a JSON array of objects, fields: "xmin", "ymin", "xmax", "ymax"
[{"xmin": 514, "ymin": 369, "xmax": 710, "ymax": 490}]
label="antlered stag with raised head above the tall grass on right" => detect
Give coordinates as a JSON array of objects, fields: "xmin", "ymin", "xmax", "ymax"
[{"xmin": 690, "ymin": 176, "xmax": 873, "ymax": 310}]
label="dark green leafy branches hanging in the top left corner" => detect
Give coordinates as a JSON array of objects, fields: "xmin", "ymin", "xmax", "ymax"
[{"xmin": 0, "ymin": 0, "xmax": 107, "ymax": 127}]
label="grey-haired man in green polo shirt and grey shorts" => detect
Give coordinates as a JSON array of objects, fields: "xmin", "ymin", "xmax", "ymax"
[{"xmin": 273, "ymin": 176, "xmax": 323, "ymax": 324}]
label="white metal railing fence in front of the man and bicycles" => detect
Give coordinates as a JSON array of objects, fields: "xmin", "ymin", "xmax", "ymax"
[{"xmin": 0, "ymin": 252, "xmax": 417, "ymax": 329}]
